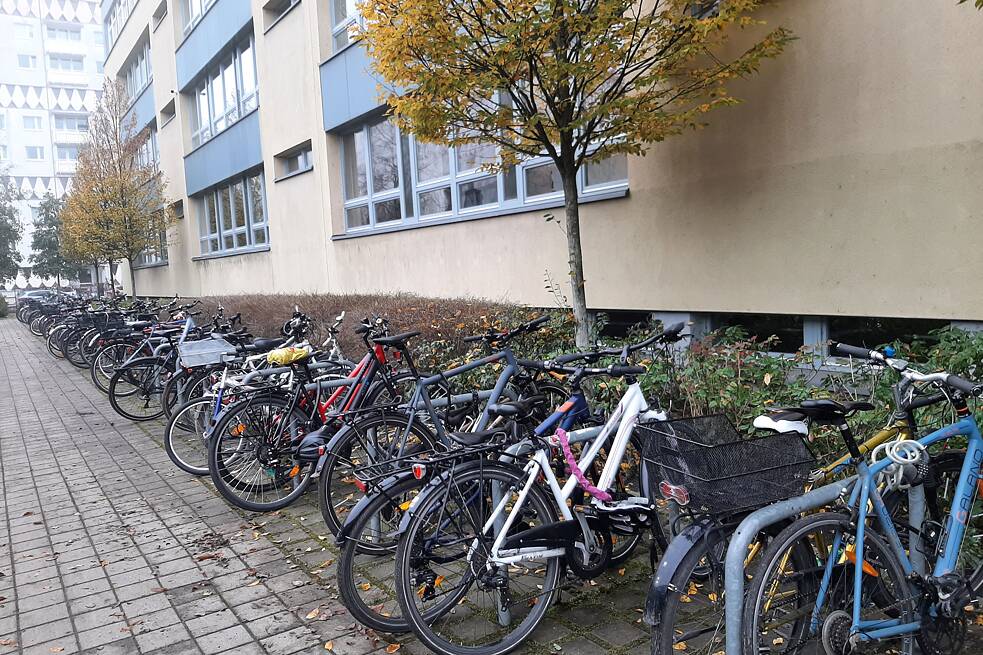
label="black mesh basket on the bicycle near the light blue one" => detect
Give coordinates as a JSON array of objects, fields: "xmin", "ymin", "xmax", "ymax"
[{"xmin": 636, "ymin": 414, "xmax": 815, "ymax": 515}]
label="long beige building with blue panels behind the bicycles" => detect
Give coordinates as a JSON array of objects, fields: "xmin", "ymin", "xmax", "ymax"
[{"xmin": 102, "ymin": 0, "xmax": 983, "ymax": 350}]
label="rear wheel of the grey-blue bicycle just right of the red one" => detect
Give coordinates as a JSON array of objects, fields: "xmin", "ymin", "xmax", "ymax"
[{"xmin": 317, "ymin": 413, "xmax": 433, "ymax": 535}]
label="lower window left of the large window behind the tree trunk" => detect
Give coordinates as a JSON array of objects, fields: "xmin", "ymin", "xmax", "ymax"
[{"xmin": 199, "ymin": 171, "xmax": 269, "ymax": 255}]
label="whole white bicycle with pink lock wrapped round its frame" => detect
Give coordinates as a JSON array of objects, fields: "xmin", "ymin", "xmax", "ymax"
[{"xmin": 395, "ymin": 323, "xmax": 683, "ymax": 655}]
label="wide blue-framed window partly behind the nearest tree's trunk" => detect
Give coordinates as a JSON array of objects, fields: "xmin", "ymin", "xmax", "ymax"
[{"xmin": 341, "ymin": 120, "xmax": 628, "ymax": 230}]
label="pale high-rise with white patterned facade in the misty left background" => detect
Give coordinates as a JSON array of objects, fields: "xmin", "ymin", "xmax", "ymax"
[{"xmin": 0, "ymin": 0, "xmax": 105, "ymax": 288}]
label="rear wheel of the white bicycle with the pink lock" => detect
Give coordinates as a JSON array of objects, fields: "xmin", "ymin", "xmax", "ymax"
[{"xmin": 396, "ymin": 462, "xmax": 560, "ymax": 655}]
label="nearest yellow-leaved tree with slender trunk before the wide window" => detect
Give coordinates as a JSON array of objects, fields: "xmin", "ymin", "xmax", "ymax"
[{"xmin": 361, "ymin": 0, "xmax": 792, "ymax": 346}]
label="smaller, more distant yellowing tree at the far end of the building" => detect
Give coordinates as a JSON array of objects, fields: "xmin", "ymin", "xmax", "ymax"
[{"xmin": 62, "ymin": 79, "xmax": 174, "ymax": 297}]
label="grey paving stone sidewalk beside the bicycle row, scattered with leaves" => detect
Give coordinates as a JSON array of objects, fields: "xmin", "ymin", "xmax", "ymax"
[{"xmin": 0, "ymin": 318, "xmax": 649, "ymax": 655}]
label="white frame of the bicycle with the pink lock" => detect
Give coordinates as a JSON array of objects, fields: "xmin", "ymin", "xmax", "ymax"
[{"xmin": 482, "ymin": 382, "xmax": 666, "ymax": 564}]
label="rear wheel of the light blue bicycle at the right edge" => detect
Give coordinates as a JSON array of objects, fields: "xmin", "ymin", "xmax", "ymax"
[{"xmin": 743, "ymin": 512, "xmax": 918, "ymax": 654}]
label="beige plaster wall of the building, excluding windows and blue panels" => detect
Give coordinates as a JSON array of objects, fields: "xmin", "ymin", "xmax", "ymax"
[{"xmin": 107, "ymin": 0, "xmax": 983, "ymax": 328}]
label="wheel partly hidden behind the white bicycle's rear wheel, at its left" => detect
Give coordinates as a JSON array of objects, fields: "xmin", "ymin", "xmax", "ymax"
[{"xmin": 337, "ymin": 477, "xmax": 426, "ymax": 633}]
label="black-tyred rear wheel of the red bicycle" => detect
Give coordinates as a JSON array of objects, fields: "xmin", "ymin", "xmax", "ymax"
[{"xmin": 208, "ymin": 396, "xmax": 315, "ymax": 512}]
